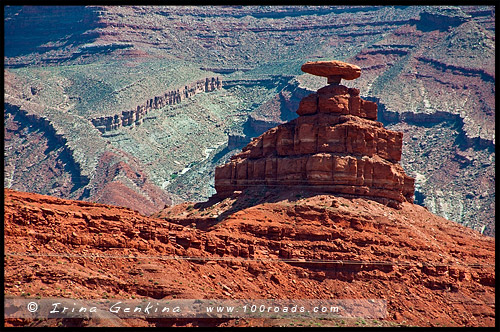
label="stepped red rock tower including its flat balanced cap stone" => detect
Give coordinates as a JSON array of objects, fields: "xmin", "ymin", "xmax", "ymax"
[{"xmin": 215, "ymin": 61, "xmax": 415, "ymax": 207}]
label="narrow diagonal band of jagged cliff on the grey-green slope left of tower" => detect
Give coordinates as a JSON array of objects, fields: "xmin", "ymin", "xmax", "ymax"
[{"xmin": 91, "ymin": 77, "xmax": 222, "ymax": 133}]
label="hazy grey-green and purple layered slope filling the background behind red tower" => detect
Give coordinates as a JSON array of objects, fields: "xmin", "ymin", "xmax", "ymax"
[{"xmin": 4, "ymin": 6, "xmax": 495, "ymax": 235}]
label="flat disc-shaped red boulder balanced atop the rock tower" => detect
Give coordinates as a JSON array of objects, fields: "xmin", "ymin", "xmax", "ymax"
[{"xmin": 301, "ymin": 60, "xmax": 361, "ymax": 84}]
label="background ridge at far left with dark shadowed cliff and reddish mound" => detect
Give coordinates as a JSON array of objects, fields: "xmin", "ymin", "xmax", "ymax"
[{"xmin": 4, "ymin": 85, "xmax": 173, "ymax": 213}]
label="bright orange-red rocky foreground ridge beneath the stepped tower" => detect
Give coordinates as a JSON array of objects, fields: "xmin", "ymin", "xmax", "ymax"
[{"xmin": 4, "ymin": 188, "xmax": 495, "ymax": 326}]
